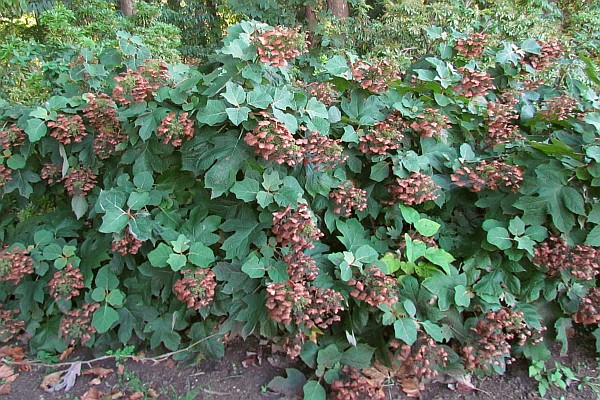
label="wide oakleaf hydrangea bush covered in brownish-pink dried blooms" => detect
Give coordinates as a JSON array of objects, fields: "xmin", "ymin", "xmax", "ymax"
[{"xmin": 0, "ymin": 22, "xmax": 600, "ymax": 399}]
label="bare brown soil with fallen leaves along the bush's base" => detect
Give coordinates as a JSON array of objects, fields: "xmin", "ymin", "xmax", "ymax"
[{"xmin": 0, "ymin": 339, "xmax": 600, "ymax": 400}]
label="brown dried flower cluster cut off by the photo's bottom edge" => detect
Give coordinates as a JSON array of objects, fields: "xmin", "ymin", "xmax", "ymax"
[{"xmin": 331, "ymin": 365, "xmax": 385, "ymax": 400}]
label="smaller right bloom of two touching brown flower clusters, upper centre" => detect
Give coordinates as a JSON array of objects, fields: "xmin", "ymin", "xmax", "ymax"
[{"xmin": 302, "ymin": 132, "xmax": 348, "ymax": 170}]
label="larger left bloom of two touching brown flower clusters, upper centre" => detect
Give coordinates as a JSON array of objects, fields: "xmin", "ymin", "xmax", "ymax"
[{"xmin": 244, "ymin": 112, "xmax": 304, "ymax": 166}]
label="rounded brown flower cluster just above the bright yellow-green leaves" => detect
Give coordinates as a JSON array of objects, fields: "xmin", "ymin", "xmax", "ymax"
[{"xmin": 388, "ymin": 172, "xmax": 440, "ymax": 206}]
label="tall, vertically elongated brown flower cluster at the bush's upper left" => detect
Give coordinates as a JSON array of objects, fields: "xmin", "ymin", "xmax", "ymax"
[{"xmin": 83, "ymin": 93, "xmax": 127, "ymax": 158}]
